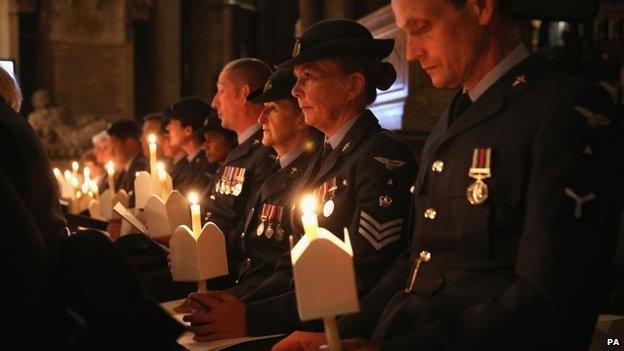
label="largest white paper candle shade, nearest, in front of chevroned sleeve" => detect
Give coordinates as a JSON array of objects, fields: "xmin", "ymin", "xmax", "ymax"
[{"xmin": 290, "ymin": 228, "xmax": 359, "ymax": 321}]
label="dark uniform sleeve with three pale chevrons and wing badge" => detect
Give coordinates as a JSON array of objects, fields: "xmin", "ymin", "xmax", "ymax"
[{"xmin": 349, "ymin": 135, "xmax": 417, "ymax": 296}]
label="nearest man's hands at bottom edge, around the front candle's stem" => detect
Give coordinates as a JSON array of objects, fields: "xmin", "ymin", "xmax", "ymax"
[{"xmin": 271, "ymin": 331, "xmax": 379, "ymax": 351}]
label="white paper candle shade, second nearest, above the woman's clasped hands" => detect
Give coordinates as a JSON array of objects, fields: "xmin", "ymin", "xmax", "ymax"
[{"xmin": 169, "ymin": 222, "xmax": 228, "ymax": 282}]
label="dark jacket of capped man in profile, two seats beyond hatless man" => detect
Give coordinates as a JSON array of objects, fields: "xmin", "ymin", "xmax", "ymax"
[{"xmin": 175, "ymin": 151, "xmax": 219, "ymax": 196}]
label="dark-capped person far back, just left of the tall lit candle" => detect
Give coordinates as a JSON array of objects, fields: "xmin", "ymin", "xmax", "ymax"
[{"xmin": 107, "ymin": 120, "xmax": 149, "ymax": 206}]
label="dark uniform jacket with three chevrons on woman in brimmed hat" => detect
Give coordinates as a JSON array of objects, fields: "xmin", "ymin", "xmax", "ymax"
[{"xmin": 247, "ymin": 110, "xmax": 417, "ymax": 335}]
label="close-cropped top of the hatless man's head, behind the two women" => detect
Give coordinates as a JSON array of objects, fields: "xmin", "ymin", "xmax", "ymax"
[{"xmin": 222, "ymin": 58, "xmax": 271, "ymax": 91}]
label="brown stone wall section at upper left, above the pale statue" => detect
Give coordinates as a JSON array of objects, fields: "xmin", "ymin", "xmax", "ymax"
[{"xmin": 39, "ymin": 0, "xmax": 134, "ymax": 121}]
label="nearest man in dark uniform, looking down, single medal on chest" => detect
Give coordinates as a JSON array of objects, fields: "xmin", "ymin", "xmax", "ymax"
[{"xmin": 274, "ymin": 0, "xmax": 622, "ymax": 350}]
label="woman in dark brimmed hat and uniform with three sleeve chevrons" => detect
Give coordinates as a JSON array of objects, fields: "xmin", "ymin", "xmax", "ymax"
[{"xmin": 183, "ymin": 20, "xmax": 416, "ymax": 347}]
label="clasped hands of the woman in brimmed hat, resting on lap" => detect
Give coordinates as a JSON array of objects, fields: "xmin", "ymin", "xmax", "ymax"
[{"xmin": 184, "ymin": 291, "xmax": 247, "ymax": 341}]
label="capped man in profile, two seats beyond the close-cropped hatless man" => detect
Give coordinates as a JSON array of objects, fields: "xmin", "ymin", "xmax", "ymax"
[{"xmin": 166, "ymin": 96, "xmax": 218, "ymax": 196}]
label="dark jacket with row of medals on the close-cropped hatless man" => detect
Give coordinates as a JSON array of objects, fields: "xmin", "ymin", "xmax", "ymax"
[{"xmin": 202, "ymin": 130, "xmax": 276, "ymax": 264}]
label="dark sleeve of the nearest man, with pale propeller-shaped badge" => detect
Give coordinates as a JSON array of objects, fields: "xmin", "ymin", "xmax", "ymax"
[{"xmin": 381, "ymin": 86, "xmax": 622, "ymax": 350}]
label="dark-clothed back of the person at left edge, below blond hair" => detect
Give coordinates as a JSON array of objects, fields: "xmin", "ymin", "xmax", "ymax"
[{"xmin": 0, "ymin": 99, "xmax": 67, "ymax": 247}]
